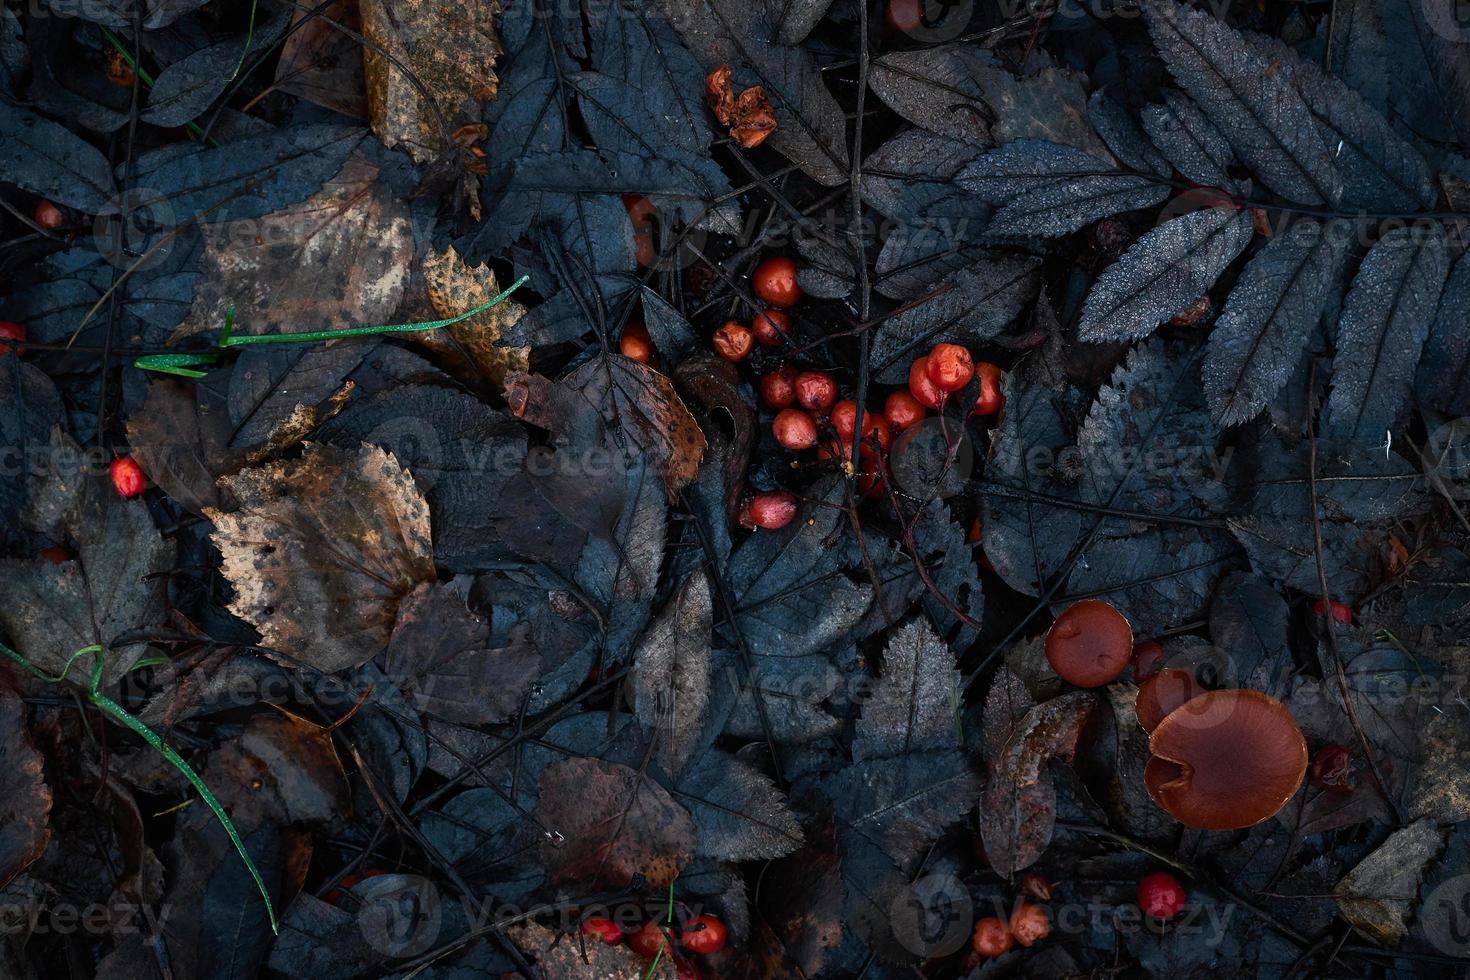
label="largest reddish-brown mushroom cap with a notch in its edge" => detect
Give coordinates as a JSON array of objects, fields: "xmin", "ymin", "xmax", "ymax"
[{"xmin": 1144, "ymin": 691, "xmax": 1307, "ymax": 830}]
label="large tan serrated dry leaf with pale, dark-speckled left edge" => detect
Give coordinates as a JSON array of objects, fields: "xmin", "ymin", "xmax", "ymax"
[{"xmin": 206, "ymin": 444, "xmax": 434, "ymax": 671}]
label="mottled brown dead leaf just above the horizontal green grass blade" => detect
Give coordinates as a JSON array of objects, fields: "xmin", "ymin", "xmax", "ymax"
[{"xmin": 172, "ymin": 157, "xmax": 413, "ymax": 341}]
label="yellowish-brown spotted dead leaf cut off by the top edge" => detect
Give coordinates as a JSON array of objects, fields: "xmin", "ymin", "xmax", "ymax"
[{"xmin": 359, "ymin": 0, "xmax": 501, "ymax": 163}]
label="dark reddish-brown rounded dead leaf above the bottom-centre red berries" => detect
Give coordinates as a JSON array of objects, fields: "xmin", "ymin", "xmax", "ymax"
[{"xmin": 535, "ymin": 758, "xmax": 695, "ymax": 890}]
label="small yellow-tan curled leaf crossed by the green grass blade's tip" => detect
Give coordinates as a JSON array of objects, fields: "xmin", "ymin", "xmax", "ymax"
[{"xmin": 410, "ymin": 245, "xmax": 531, "ymax": 386}]
